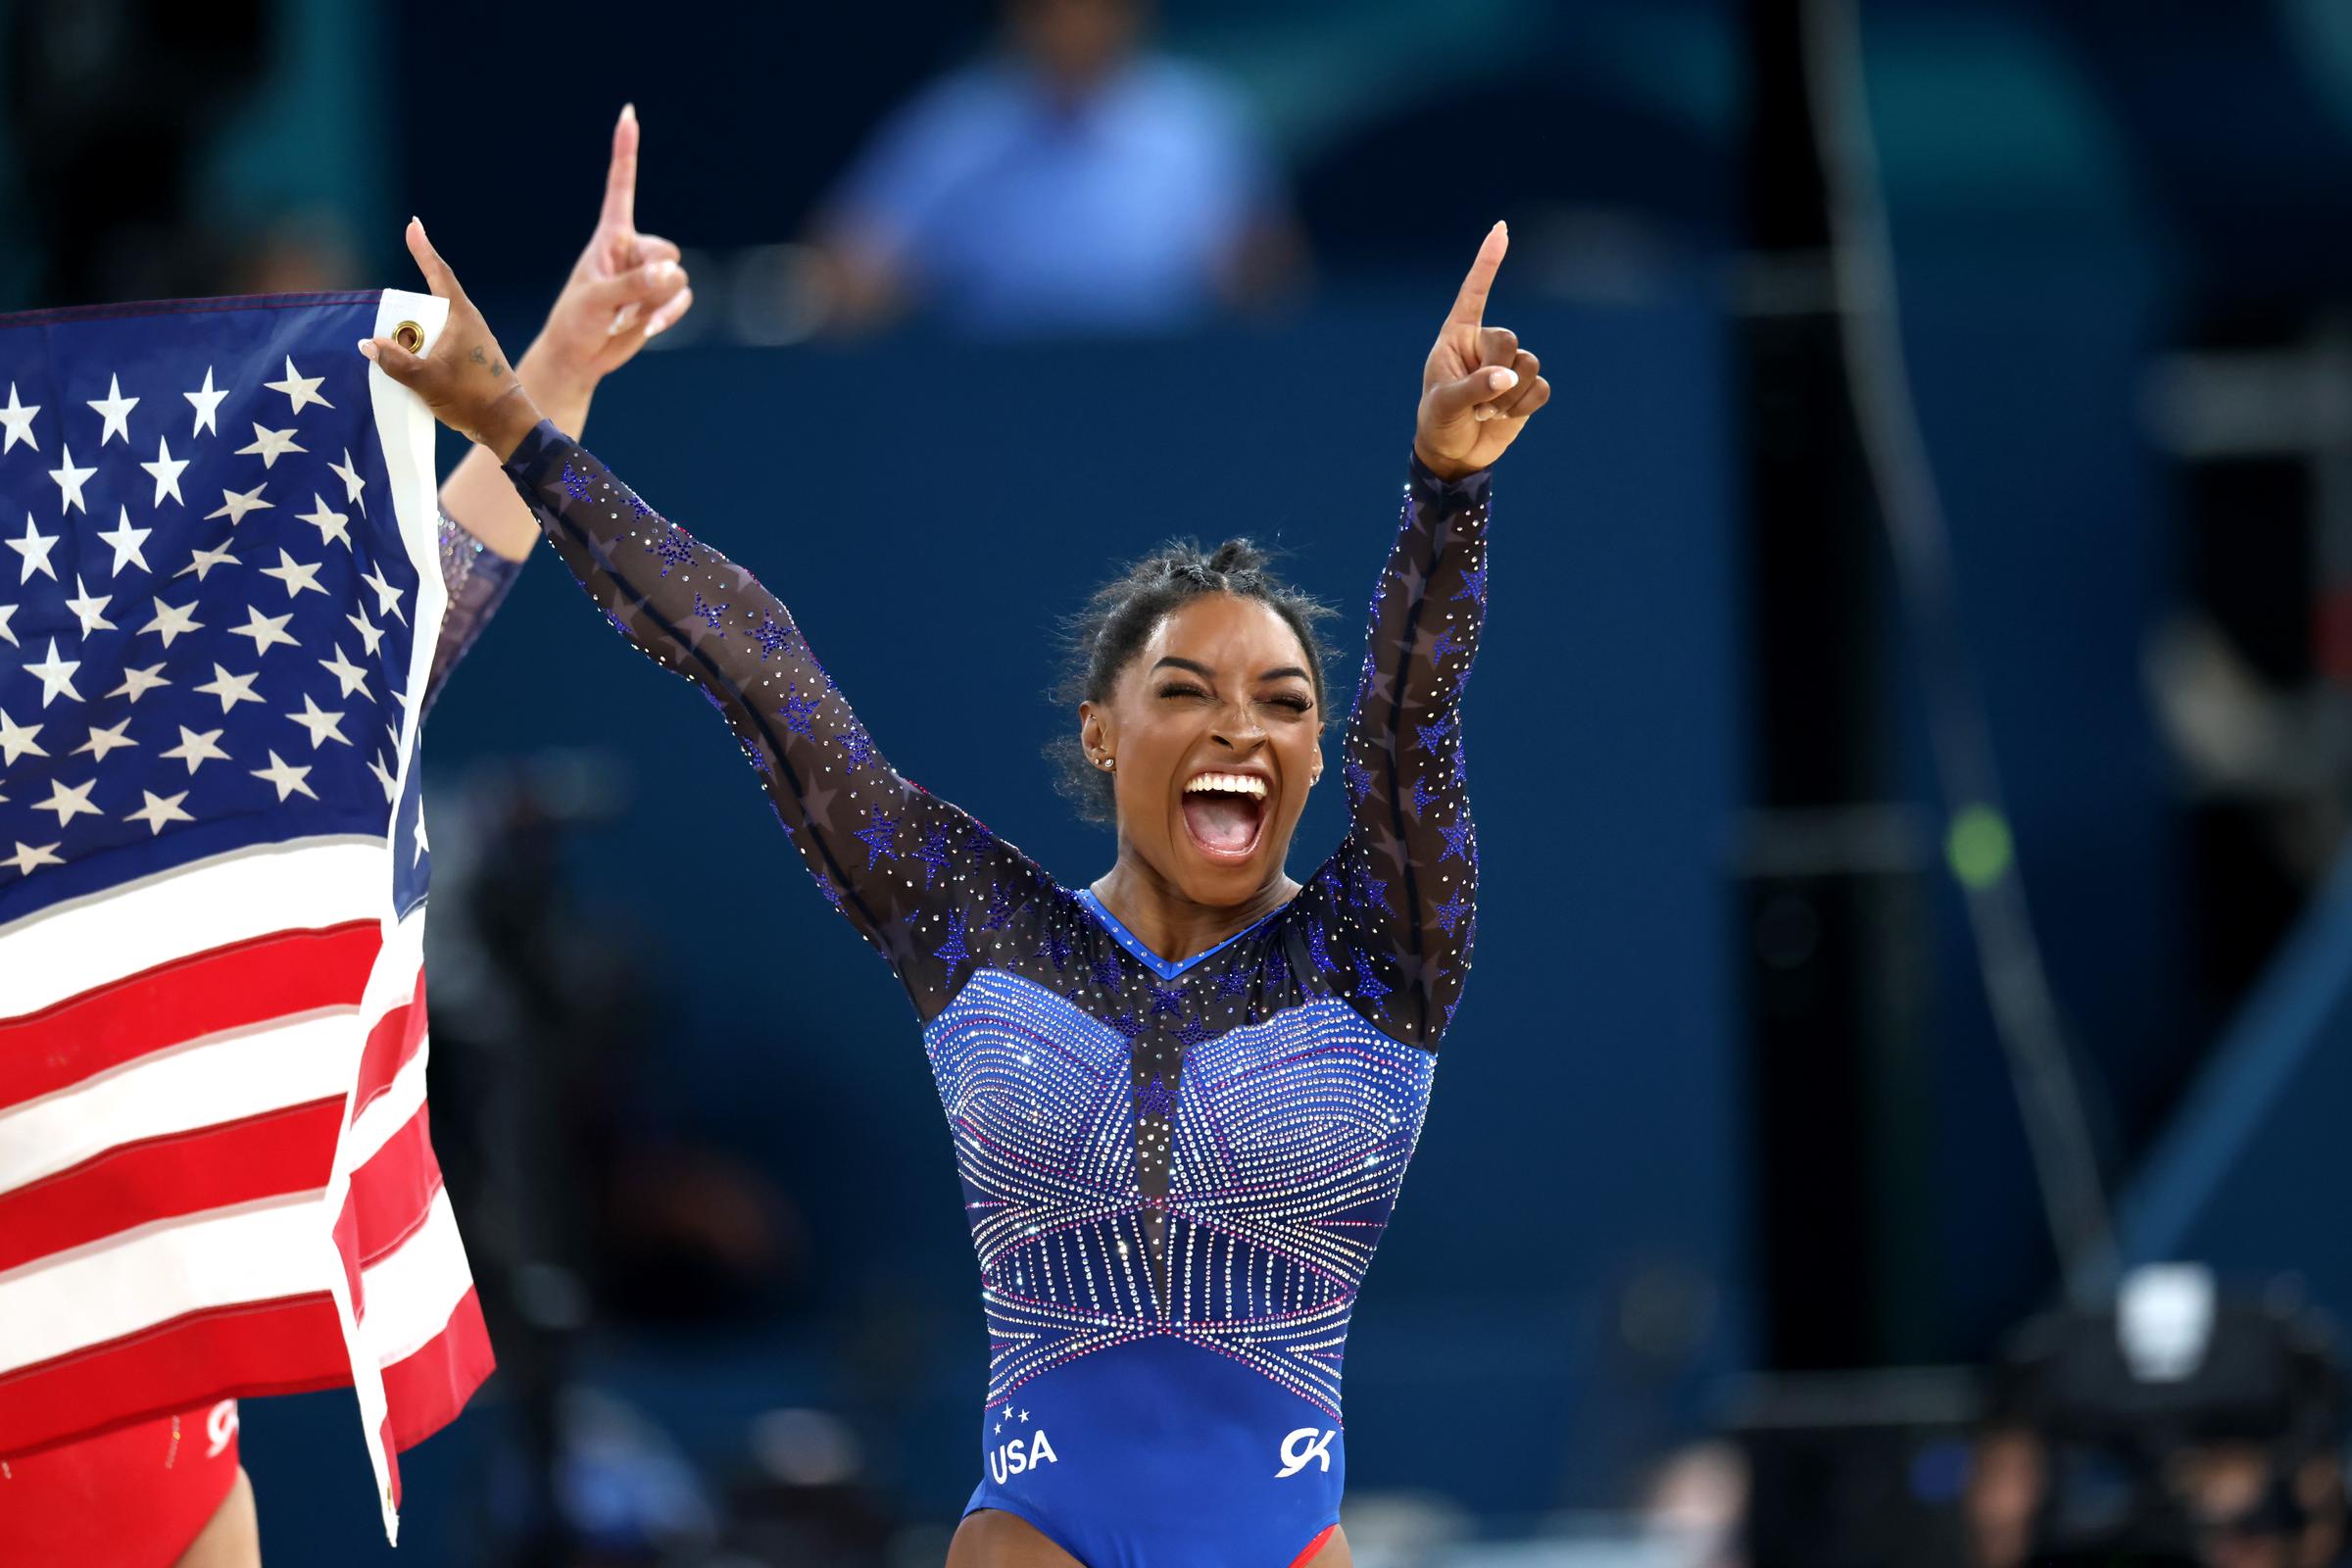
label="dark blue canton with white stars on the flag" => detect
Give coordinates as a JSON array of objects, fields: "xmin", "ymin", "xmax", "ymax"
[{"xmin": 0, "ymin": 294, "xmax": 440, "ymax": 924}]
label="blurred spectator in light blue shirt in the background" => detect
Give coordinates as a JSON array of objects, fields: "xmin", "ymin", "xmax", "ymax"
[{"xmin": 816, "ymin": 0, "xmax": 1300, "ymax": 336}]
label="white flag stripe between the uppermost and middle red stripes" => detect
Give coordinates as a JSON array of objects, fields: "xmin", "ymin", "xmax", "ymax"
[{"xmin": 0, "ymin": 1008, "xmax": 360, "ymax": 1192}]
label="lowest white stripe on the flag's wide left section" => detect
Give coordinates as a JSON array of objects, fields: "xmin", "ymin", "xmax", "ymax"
[{"xmin": 0, "ymin": 1192, "xmax": 343, "ymax": 1371}]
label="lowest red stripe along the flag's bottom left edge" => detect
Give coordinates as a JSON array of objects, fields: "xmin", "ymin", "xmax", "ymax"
[{"xmin": 0, "ymin": 1293, "xmax": 351, "ymax": 1455}]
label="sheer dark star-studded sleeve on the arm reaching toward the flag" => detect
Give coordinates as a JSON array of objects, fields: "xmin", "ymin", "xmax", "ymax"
[{"xmin": 506, "ymin": 423, "xmax": 1052, "ymax": 1020}]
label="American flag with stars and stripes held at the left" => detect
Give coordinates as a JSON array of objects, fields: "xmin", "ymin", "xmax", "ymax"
[{"xmin": 0, "ymin": 291, "xmax": 492, "ymax": 1531}]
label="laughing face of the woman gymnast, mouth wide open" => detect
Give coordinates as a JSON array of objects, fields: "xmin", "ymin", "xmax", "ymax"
[{"xmin": 1080, "ymin": 592, "xmax": 1324, "ymax": 907}]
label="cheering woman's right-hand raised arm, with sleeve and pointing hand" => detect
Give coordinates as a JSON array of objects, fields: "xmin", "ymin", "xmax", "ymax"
[{"xmin": 1303, "ymin": 223, "xmax": 1550, "ymax": 1049}]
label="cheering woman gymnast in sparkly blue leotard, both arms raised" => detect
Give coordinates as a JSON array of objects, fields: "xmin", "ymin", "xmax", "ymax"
[{"xmin": 360, "ymin": 211, "xmax": 1550, "ymax": 1568}]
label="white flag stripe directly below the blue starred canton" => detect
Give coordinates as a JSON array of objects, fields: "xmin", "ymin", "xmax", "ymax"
[{"xmin": 0, "ymin": 837, "xmax": 385, "ymax": 1018}]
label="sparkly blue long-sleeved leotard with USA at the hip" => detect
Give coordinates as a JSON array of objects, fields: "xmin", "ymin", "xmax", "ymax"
[{"xmin": 508, "ymin": 425, "xmax": 1487, "ymax": 1568}]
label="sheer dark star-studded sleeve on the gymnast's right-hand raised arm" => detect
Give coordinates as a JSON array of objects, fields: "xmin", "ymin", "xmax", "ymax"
[{"xmin": 1296, "ymin": 459, "xmax": 1492, "ymax": 1051}]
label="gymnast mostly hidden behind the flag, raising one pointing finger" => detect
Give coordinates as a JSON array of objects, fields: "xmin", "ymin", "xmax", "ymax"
[{"xmin": 0, "ymin": 108, "xmax": 694, "ymax": 1568}]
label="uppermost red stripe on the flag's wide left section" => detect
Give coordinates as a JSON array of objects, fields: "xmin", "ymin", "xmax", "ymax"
[{"xmin": 0, "ymin": 921, "xmax": 383, "ymax": 1107}]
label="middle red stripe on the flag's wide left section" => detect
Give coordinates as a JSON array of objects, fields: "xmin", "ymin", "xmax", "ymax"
[{"xmin": 0, "ymin": 1098, "xmax": 343, "ymax": 1272}]
